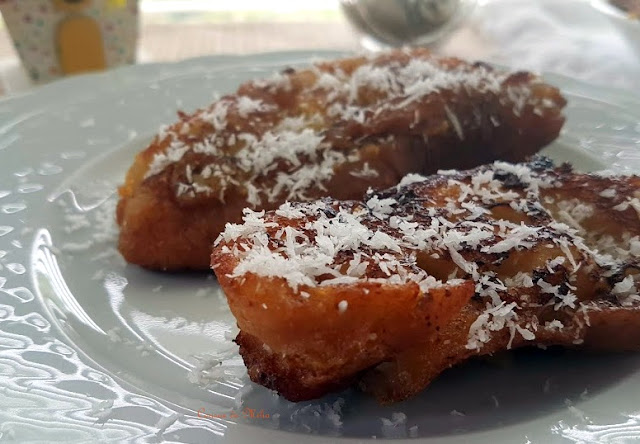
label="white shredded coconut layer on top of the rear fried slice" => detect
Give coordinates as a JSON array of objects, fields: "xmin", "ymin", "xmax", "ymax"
[{"xmin": 145, "ymin": 50, "xmax": 554, "ymax": 209}]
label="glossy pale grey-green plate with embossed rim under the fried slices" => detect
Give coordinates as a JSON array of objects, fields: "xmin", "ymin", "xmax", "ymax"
[{"xmin": 0, "ymin": 52, "xmax": 640, "ymax": 443}]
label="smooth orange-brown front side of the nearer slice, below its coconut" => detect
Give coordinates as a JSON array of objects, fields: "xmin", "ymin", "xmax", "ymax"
[{"xmin": 216, "ymin": 245, "xmax": 473, "ymax": 401}]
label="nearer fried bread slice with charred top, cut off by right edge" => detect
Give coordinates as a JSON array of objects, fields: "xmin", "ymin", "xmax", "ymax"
[{"xmin": 212, "ymin": 159, "xmax": 640, "ymax": 403}]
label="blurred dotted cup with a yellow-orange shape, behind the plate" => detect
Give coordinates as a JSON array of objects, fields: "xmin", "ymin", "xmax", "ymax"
[{"xmin": 0, "ymin": 0, "xmax": 138, "ymax": 82}]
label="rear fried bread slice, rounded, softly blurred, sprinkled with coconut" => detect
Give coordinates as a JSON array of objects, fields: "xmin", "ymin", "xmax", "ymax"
[{"xmin": 117, "ymin": 49, "xmax": 565, "ymax": 269}]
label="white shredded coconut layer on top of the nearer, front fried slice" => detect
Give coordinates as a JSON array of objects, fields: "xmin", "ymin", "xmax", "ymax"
[{"xmin": 216, "ymin": 159, "xmax": 640, "ymax": 350}]
